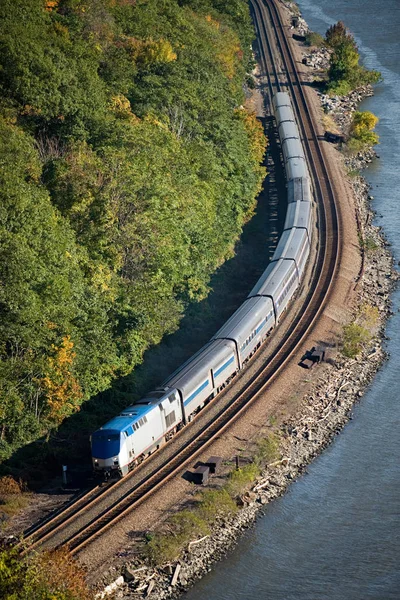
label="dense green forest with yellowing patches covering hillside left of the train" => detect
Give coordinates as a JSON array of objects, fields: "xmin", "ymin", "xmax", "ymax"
[{"xmin": 0, "ymin": 0, "xmax": 265, "ymax": 458}]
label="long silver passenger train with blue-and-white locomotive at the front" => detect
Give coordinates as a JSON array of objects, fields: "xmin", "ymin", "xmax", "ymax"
[{"xmin": 91, "ymin": 92, "xmax": 313, "ymax": 478}]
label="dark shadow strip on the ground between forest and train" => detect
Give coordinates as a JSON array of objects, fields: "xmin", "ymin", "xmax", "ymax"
[{"xmin": 4, "ymin": 118, "xmax": 286, "ymax": 479}]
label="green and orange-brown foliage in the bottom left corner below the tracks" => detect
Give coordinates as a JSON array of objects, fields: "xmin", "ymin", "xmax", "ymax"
[{"xmin": 0, "ymin": 549, "xmax": 94, "ymax": 600}]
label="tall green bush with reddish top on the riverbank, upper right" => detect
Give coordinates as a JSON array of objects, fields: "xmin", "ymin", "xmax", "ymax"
[{"xmin": 325, "ymin": 21, "xmax": 381, "ymax": 96}]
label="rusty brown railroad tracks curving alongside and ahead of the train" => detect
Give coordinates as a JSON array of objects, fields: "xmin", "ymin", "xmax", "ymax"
[{"xmin": 22, "ymin": 0, "xmax": 340, "ymax": 554}]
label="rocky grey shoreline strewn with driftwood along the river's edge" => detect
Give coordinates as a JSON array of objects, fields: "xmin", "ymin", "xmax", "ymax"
[{"xmin": 93, "ymin": 18, "xmax": 399, "ymax": 600}]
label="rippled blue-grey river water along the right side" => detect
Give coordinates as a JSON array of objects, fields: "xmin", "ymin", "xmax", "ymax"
[{"xmin": 185, "ymin": 0, "xmax": 400, "ymax": 600}]
